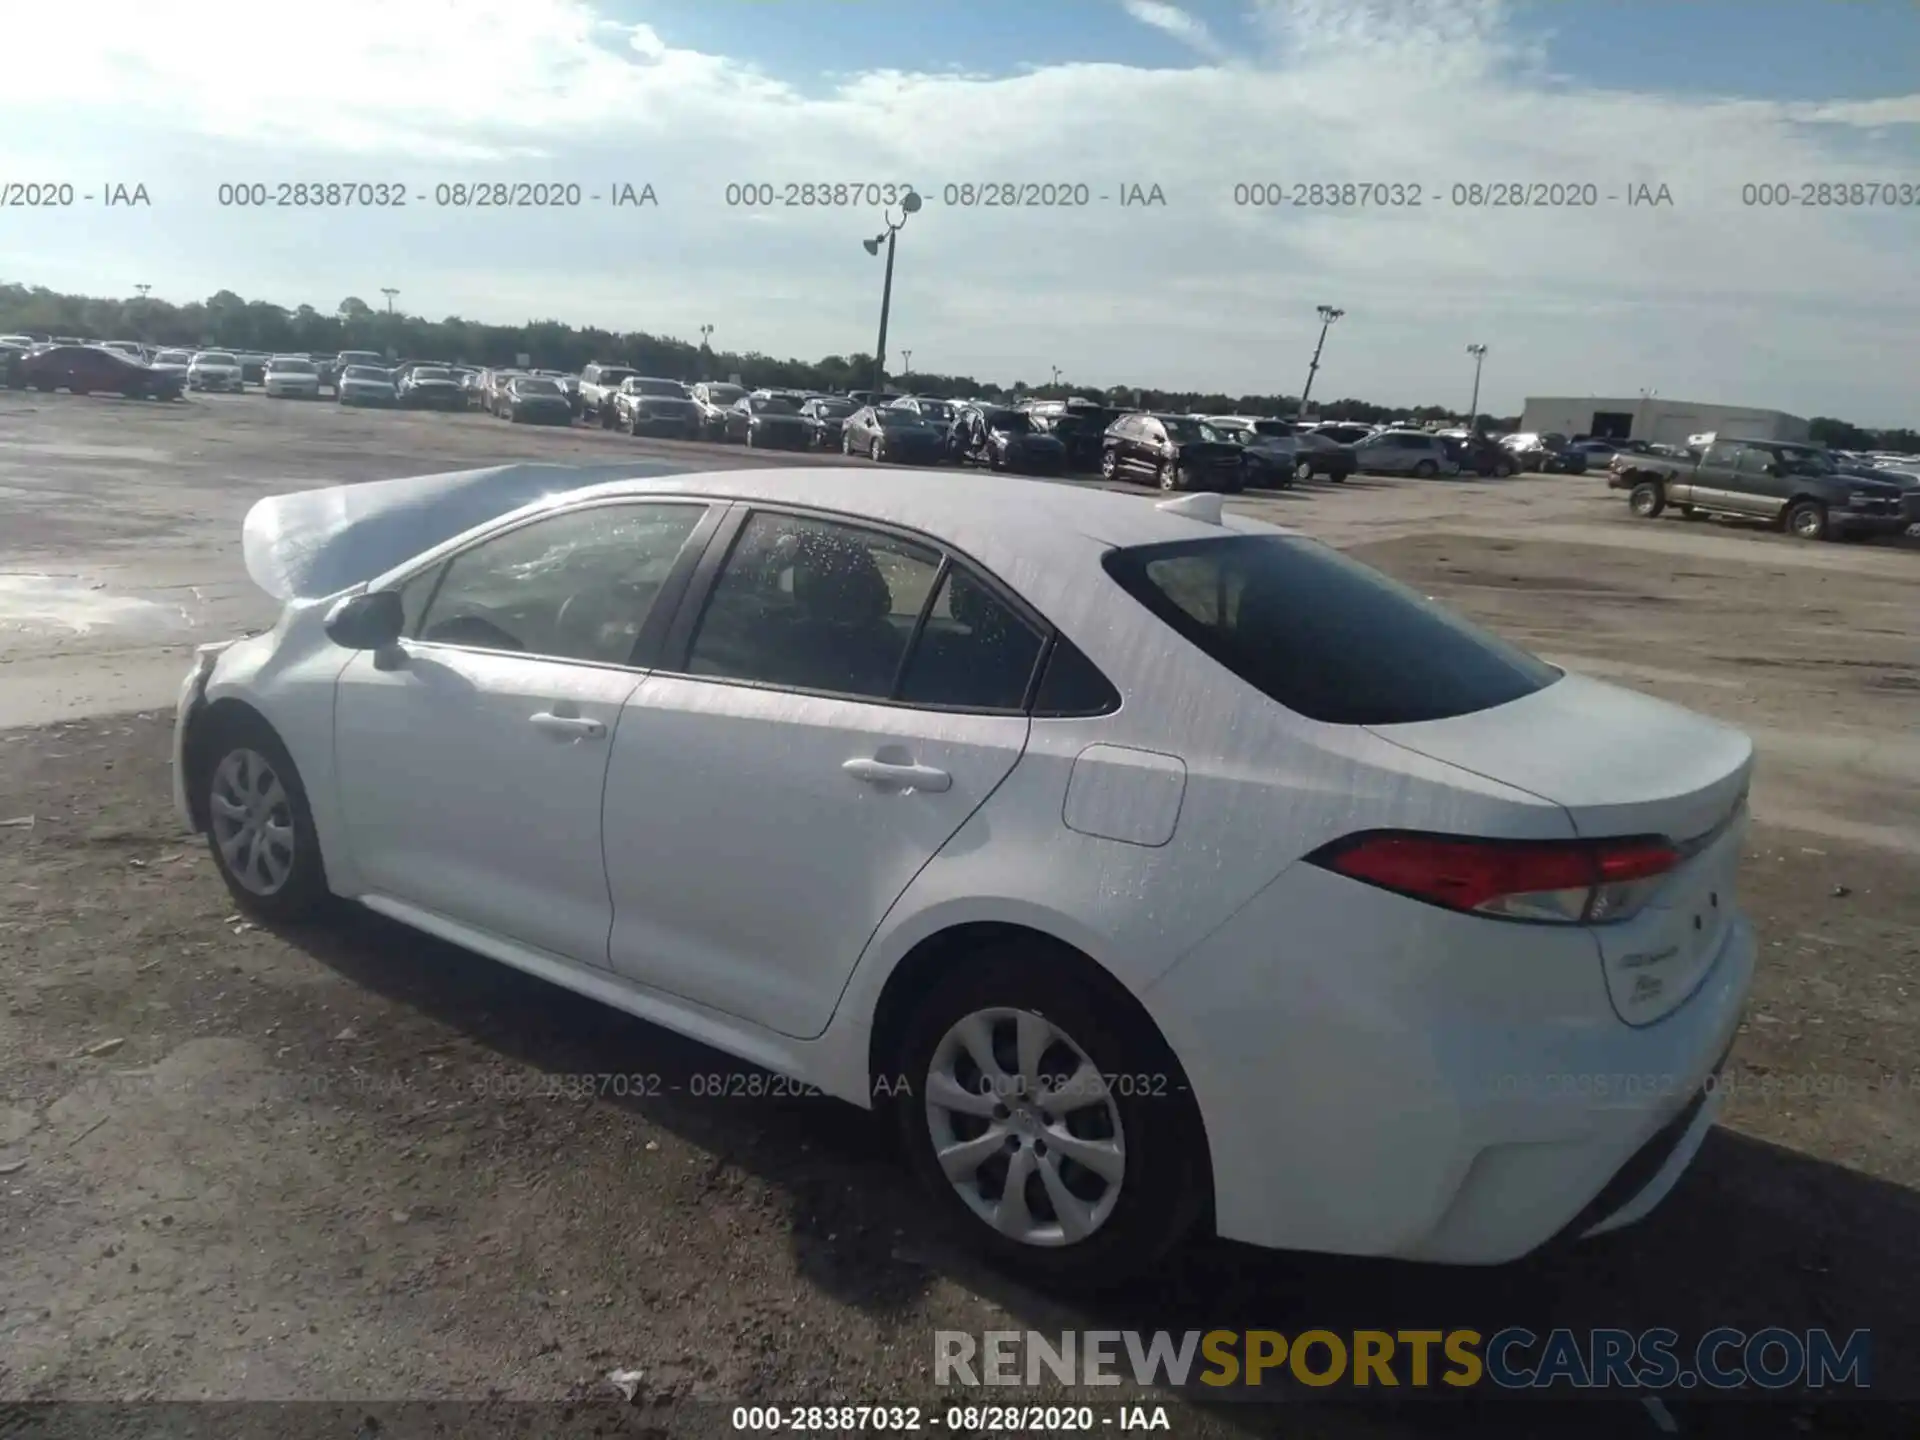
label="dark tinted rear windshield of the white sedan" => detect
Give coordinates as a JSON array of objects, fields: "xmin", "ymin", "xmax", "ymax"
[{"xmin": 1104, "ymin": 536, "xmax": 1561, "ymax": 726}]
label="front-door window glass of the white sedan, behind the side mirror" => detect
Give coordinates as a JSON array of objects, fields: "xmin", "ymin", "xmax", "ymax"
[{"xmin": 403, "ymin": 503, "xmax": 705, "ymax": 664}]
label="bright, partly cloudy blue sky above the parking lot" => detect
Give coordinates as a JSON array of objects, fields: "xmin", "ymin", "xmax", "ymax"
[{"xmin": 0, "ymin": 0, "xmax": 1920, "ymax": 424}]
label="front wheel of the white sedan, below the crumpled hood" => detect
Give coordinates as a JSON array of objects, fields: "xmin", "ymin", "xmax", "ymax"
[{"xmin": 200, "ymin": 714, "xmax": 328, "ymax": 922}]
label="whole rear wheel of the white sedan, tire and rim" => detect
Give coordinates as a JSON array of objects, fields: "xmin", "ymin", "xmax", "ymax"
[{"xmin": 893, "ymin": 945, "xmax": 1208, "ymax": 1284}]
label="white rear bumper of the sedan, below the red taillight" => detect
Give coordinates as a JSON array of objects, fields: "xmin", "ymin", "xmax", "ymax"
[{"xmin": 1144, "ymin": 866, "xmax": 1755, "ymax": 1265}]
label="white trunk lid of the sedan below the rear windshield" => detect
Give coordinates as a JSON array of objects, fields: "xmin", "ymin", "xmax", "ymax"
[{"xmin": 1373, "ymin": 674, "xmax": 1753, "ymax": 1025}]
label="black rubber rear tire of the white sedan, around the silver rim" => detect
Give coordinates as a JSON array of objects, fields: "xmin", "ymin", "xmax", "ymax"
[{"xmin": 891, "ymin": 941, "xmax": 1210, "ymax": 1288}]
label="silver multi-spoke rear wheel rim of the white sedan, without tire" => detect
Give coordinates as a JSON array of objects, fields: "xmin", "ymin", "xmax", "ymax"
[{"xmin": 925, "ymin": 1008, "xmax": 1127, "ymax": 1248}]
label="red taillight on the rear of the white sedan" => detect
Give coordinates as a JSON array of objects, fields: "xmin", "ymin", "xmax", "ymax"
[{"xmin": 1311, "ymin": 831, "xmax": 1680, "ymax": 924}]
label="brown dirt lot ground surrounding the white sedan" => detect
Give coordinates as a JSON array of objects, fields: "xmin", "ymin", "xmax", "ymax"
[{"xmin": 0, "ymin": 396, "xmax": 1920, "ymax": 1436}]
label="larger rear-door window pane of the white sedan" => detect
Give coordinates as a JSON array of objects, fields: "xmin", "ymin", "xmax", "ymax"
[{"xmin": 687, "ymin": 511, "xmax": 941, "ymax": 701}]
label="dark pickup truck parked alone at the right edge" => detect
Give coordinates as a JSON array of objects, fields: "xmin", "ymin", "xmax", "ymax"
[{"xmin": 1607, "ymin": 436, "xmax": 1912, "ymax": 540}]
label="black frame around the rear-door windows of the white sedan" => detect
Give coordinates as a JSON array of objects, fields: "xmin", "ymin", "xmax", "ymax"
[{"xmin": 653, "ymin": 501, "xmax": 1052, "ymax": 716}]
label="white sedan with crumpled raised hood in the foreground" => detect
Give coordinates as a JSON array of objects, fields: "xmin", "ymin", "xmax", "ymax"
[{"xmin": 175, "ymin": 467, "xmax": 1755, "ymax": 1281}]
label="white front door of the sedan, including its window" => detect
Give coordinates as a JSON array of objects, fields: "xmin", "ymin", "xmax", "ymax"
[{"xmin": 334, "ymin": 503, "xmax": 707, "ymax": 966}]
